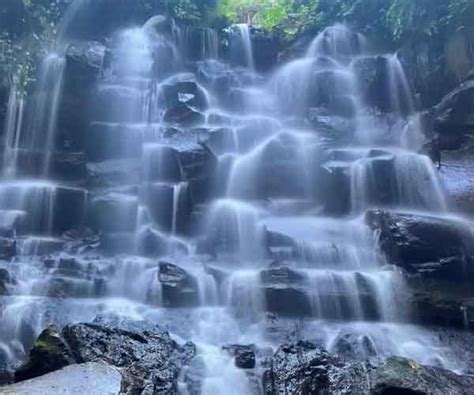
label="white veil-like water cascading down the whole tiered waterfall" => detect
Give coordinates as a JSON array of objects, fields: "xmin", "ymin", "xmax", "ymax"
[{"xmin": 0, "ymin": 7, "xmax": 470, "ymax": 394}]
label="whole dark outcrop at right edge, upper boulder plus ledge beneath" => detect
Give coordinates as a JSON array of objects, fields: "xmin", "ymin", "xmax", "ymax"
[{"xmin": 366, "ymin": 211, "xmax": 474, "ymax": 328}]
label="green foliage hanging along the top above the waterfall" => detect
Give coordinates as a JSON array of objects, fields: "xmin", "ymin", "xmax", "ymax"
[{"xmin": 0, "ymin": 0, "xmax": 474, "ymax": 92}]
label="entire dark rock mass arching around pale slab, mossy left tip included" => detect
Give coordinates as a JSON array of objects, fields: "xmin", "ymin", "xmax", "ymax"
[{"xmin": 15, "ymin": 324, "xmax": 194, "ymax": 394}]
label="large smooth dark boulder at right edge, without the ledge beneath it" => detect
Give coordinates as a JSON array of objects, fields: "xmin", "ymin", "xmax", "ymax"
[{"xmin": 365, "ymin": 210, "xmax": 474, "ymax": 282}]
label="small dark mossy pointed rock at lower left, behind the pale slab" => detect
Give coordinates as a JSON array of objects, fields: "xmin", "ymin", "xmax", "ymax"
[{"xmin": 15, "ymin": 327, "xmax": 74, "ymax": 381}]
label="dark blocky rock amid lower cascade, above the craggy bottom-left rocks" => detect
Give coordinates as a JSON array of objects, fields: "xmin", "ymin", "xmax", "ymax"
[{"xmin": 158, "ymin": 262, "xmax": 198, "ymax": 307}]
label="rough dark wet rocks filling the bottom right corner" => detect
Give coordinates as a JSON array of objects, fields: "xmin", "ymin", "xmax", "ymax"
[{"xmin": 263, "ymin": 341, "xmax": 474, "ymax": 395}]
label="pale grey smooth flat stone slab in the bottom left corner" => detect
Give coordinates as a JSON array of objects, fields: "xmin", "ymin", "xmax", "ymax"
[{"xmin": 0, "ymin": 362, "xmax": 122, "ymax": 395}]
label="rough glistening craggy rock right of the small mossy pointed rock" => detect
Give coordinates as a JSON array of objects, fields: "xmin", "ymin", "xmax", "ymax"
[{"xmin": 63, "ymin": 324, "xmax": 190, "ymax": 394}]
